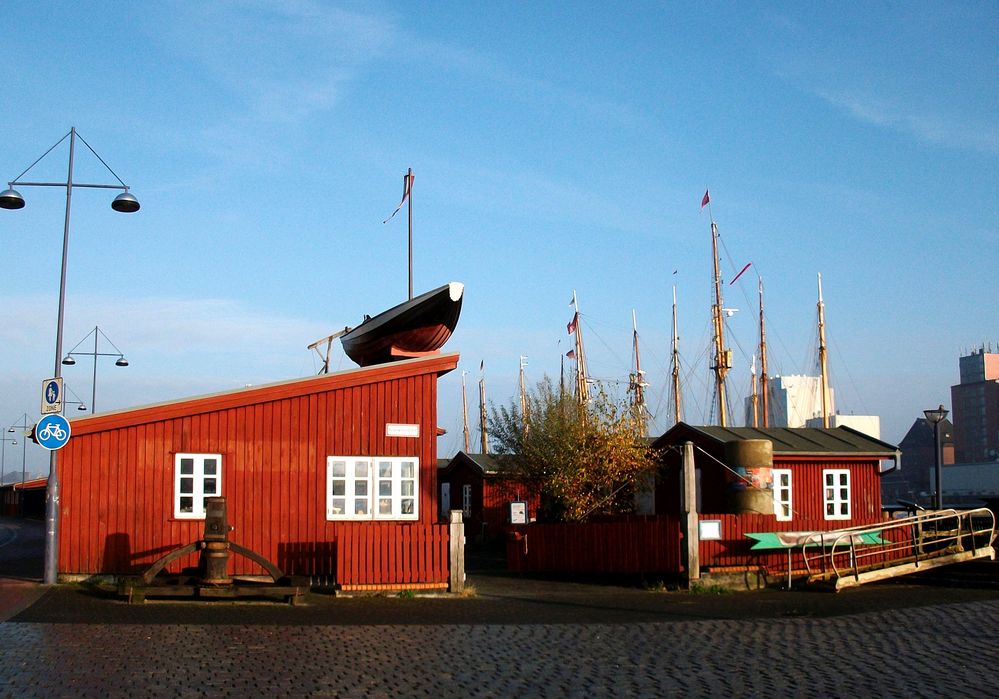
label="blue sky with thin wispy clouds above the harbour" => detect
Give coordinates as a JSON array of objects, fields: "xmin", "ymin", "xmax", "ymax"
[{"xmin": 0, "ymin": 2, "xmax": 999, "ymax": 471}]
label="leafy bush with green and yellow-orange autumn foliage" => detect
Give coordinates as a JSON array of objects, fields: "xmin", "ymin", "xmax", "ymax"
[{"xmin": 490, "ymin": 376, "xmax": 654, "ymax": 521}]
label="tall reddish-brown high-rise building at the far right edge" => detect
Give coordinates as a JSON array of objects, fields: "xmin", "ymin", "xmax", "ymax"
[{"xmin": 950, "ymin": 345, "xmax": 999, "ymax": 464}]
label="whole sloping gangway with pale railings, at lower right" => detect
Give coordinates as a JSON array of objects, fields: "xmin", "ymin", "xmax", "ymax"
[{"xmin": 801, "ymin": 507, "xmax": 996, "ymax": 590}]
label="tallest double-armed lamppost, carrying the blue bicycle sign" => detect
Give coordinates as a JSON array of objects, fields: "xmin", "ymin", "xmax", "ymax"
[{"xmin": 0, "ymin": 127, "xmax": 139, "ymax": 585}]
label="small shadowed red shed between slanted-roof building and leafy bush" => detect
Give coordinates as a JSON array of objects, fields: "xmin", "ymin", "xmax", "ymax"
[{"xmin": 438, "ymin": 451, "xmax": 540, "ymax": 543}]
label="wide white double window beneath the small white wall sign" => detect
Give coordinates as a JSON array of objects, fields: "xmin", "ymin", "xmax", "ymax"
[{"xmin": 326, "ymin": 456, "xmax": 420, "ymax": 520}]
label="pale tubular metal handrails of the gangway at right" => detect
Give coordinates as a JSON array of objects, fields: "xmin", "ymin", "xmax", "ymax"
[{"xmin": 802, "ymin": 507, "xmax": 996, "ymax": 579}]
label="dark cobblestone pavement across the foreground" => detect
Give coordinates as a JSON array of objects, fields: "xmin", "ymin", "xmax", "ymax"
[{"xmin": 0, "ymin": 600, "xmax": 999, "ymax": 697}]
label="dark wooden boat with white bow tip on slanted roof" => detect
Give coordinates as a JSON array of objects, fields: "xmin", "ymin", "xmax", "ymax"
[{"xmin": 340, "ymin": 282, "xmax": 465, "ymax": 366}]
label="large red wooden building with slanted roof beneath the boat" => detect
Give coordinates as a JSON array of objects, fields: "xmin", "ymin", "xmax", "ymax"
[{"xmin": 58, "ymin": 354, "xmax": 458, "ymax": 589}]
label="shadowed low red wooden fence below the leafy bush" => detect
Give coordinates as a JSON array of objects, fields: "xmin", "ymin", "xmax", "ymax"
[{"xmin": 507, "ymin": 517, "xmax": 680, "ymax": 574}]
